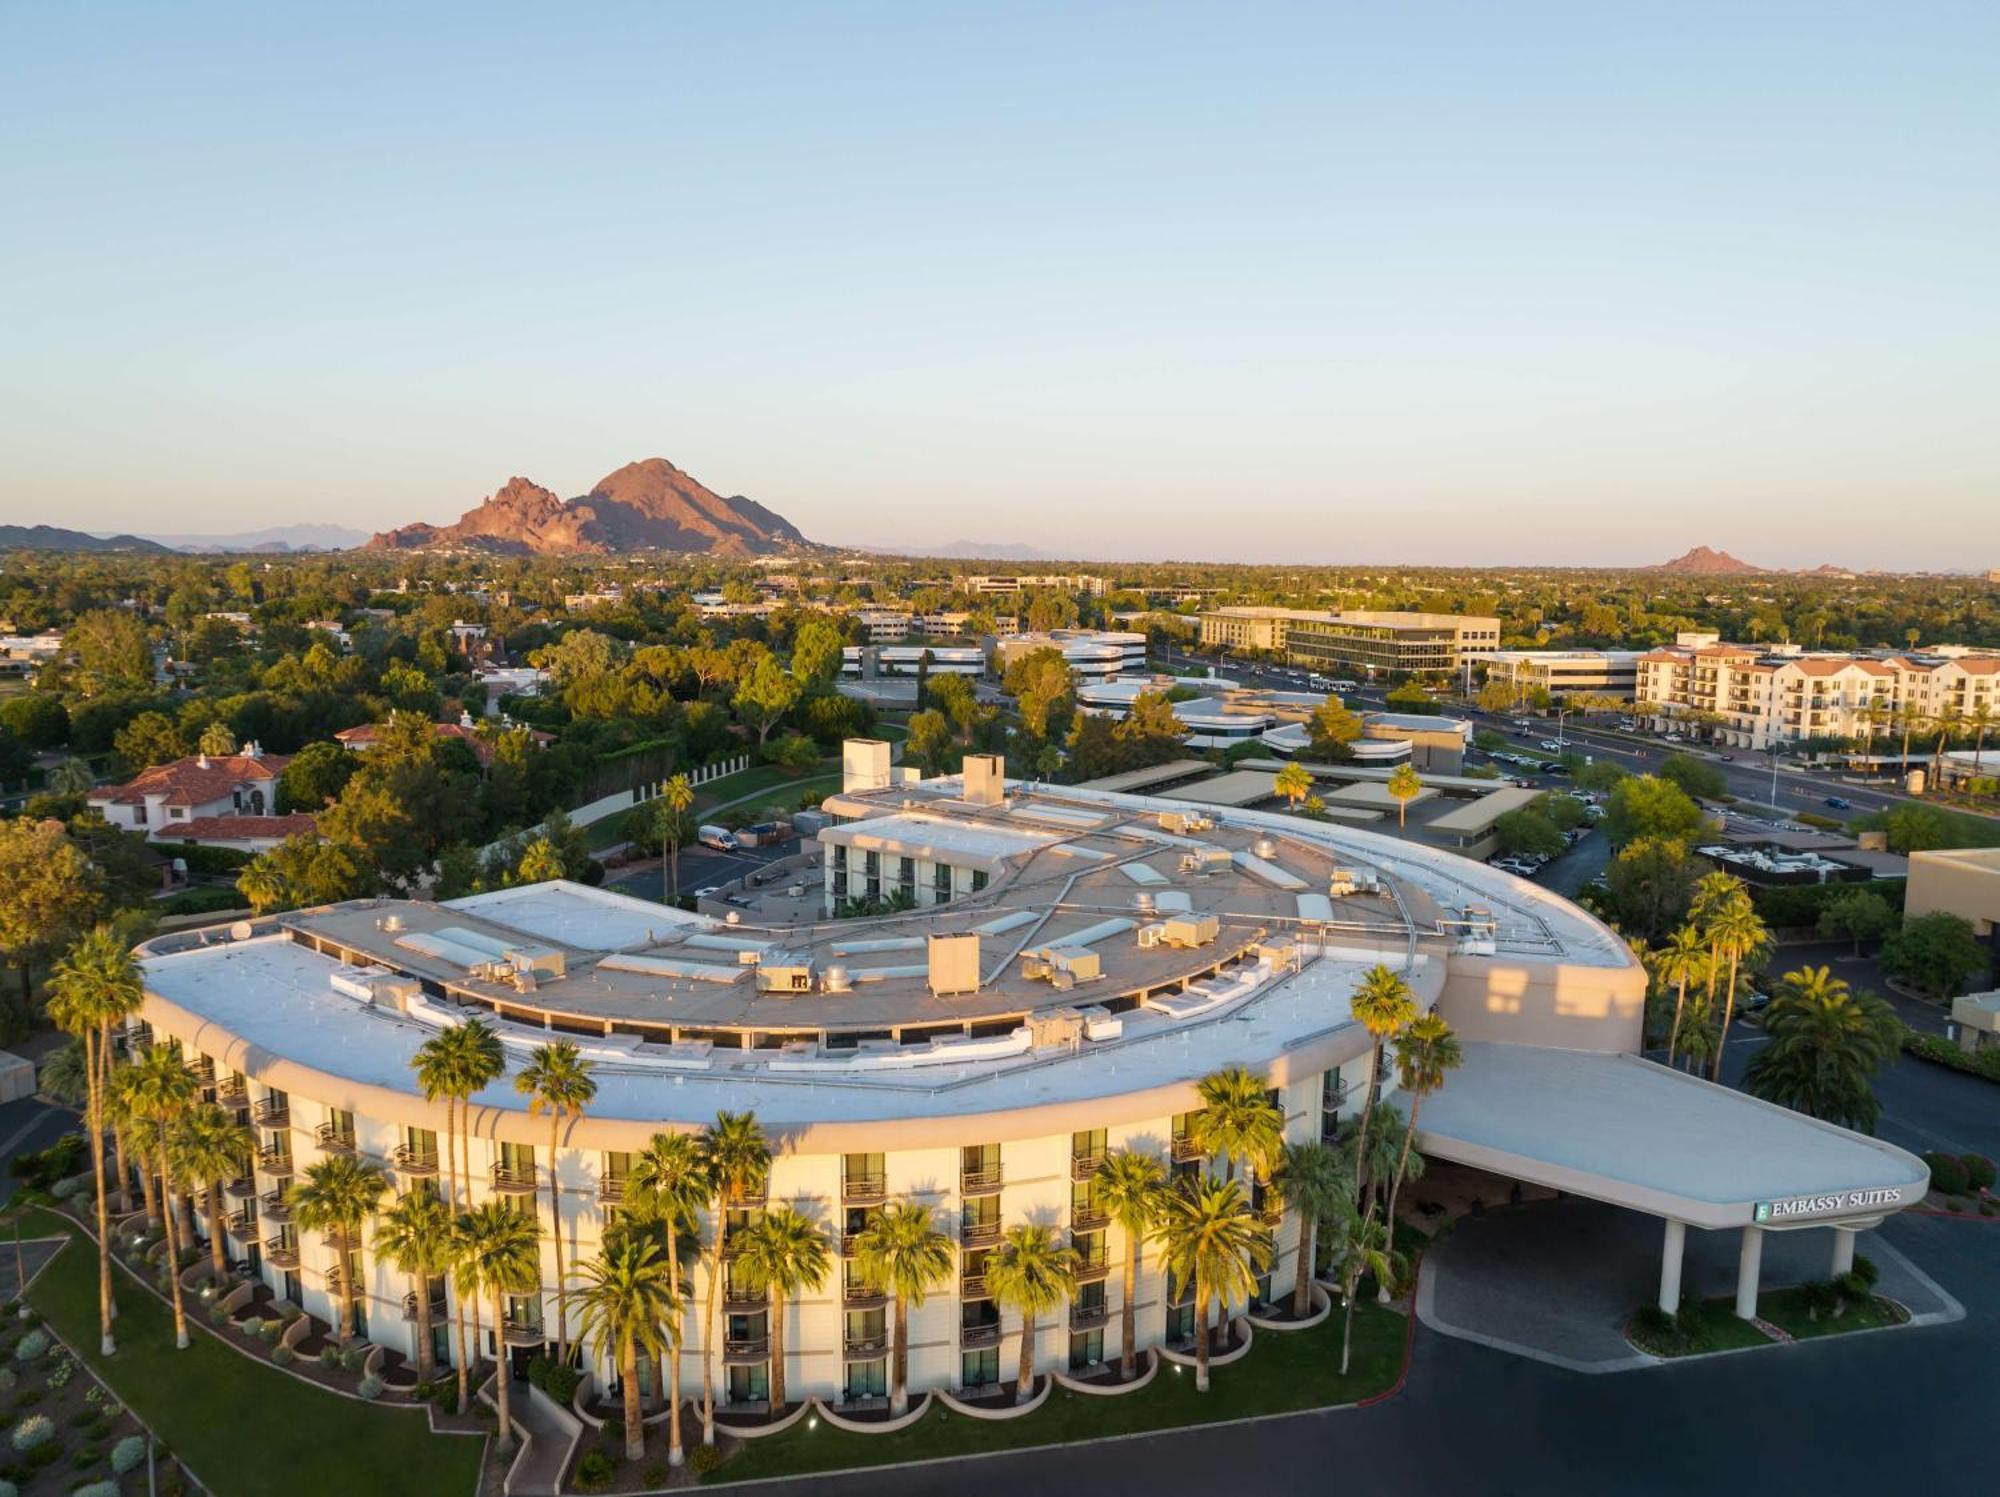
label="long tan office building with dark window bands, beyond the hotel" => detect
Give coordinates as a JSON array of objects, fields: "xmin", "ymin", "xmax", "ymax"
[{"xmin": 1202, "ymin": 608, "xmax": 1500, "ymax": 676}]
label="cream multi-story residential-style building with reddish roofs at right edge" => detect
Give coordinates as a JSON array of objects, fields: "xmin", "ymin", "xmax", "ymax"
[{"xmin": 1634, "ymin": 634, "xmax": 2000, "ymax": 749}]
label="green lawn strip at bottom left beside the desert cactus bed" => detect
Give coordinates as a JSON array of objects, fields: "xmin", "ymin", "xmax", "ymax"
[{"xmin": 11, "ymin": 1211, "xmax": 482, "ymax": 1497}]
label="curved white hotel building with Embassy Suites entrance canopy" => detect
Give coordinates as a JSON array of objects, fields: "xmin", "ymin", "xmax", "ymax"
[{"xmin": 140, "ymin": 744, "xmax": 1926, "ymax": 1405}]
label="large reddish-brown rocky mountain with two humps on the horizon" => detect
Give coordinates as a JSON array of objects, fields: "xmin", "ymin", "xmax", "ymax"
[{"xmin": 368, "ymin": 458, "xmax": 812, "ymax": 556}]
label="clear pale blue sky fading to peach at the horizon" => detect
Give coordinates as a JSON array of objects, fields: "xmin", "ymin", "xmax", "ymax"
[{"xmin": 0, "ymin": 0, "xmax": 2000, "ymax": 568}]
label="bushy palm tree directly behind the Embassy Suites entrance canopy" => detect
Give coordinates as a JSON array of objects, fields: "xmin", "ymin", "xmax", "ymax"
[{"xmin": 1744, "ymin": 967, "xmax": 1902, "ymax": 1133}]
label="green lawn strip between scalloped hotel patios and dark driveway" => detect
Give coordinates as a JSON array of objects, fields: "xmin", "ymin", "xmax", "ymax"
[{"xmin": 708, "ymin": 1303, "xmax": 1410, "ymax": 1483}]
